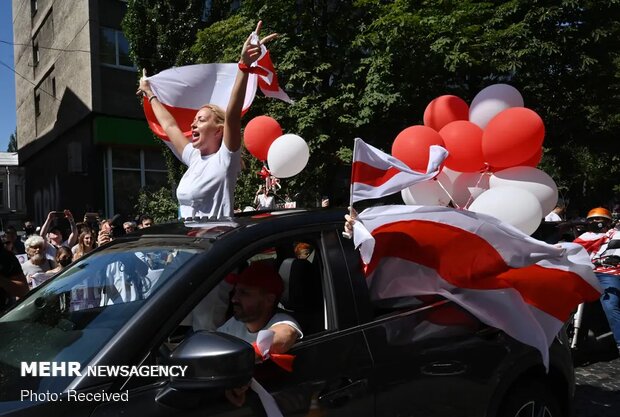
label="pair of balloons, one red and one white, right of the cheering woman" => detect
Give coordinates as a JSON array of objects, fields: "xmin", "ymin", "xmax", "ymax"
[{"xmin": 243, "ymin": 116, "xmax": 310, "ymax": 178}]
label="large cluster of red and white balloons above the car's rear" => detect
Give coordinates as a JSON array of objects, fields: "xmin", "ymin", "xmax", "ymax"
[{"xmin": 392, "ymin": 84, "xmax": 558, "ymax": 234}]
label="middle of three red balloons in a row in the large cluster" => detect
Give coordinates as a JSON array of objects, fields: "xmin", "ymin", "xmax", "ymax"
[{"xmin": 439, "ymin": 120, "xmax": 484, "ymax": 172}]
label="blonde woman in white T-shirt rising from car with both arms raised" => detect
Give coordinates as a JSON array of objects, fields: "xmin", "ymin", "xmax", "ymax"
[{"xmin": 138, "ymin": 22, "xmax": 277, "ymax": 218}]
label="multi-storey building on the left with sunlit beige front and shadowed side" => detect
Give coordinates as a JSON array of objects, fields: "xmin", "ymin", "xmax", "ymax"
[{"xmin": 12, "ymin": 0, "xmax": 166, "ymax": 224}]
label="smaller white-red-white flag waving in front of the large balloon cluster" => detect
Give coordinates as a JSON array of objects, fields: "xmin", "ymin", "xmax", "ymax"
[{"xmin": 351, "ymin": 138, "xmax": 448, "ymax": 203}]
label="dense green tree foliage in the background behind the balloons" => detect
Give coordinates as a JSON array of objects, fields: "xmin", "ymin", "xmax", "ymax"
[{"xmin": 126, "ymin": 0, "xmax": 620, "ymax": 211}]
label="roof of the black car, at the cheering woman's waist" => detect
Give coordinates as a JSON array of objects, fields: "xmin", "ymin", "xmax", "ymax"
[{"xmin": 128, "ymin": 208, "xmax": 347, "ymax": 239}]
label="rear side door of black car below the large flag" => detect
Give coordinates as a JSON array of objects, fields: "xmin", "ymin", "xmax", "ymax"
[{"xmin": 334, "ymin": 234, "xmax": 506, "ymax": 417}]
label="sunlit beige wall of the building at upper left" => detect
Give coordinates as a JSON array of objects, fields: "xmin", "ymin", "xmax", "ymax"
[{"xmin": 13, "ymin": 0, "xmax": 92, "ymax": 151}]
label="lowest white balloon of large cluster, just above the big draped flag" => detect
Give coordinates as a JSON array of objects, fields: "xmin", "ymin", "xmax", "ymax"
[{"xmin": 469, "ymin": 187, "xmax": 543, "ymax": 235}]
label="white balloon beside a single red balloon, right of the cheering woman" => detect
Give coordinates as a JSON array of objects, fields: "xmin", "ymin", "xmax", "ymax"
[{"xmin": 267, "ymin": 133, "xmax": 310, "ymax": 178}]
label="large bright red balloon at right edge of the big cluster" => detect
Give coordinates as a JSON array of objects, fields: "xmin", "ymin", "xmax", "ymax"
[{"xmin": 482, "ymin": 107, "xmax": 545, "ymax": 168}]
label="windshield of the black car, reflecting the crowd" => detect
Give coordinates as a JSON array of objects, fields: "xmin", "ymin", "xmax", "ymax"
[{"xmin": 0, "ymin": 241, "xmax": 204, "ymax": 401}]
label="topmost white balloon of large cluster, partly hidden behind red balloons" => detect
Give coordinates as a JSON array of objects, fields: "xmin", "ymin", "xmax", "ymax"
[{"xmin": 469, "ymin": 84, "xmax": 523, "ymax": 129}]
